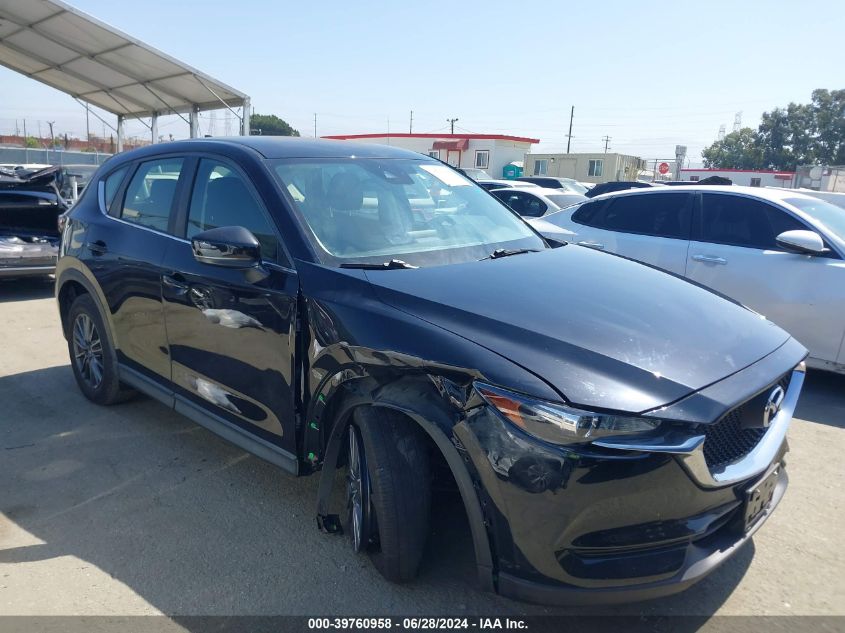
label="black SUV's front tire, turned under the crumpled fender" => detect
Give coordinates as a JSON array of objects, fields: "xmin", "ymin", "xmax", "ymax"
[{"xmin": 349, "ymin": 407, "xmax": 431, "ymax": 583}]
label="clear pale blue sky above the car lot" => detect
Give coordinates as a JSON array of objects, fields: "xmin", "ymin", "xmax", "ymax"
[{"xmin": 0, "ymin": 0, "xmax": 845, "ymax": 164}]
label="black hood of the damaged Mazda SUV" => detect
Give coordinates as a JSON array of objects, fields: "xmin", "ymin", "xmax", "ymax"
[{"xmin": 366, "ymin": 245, "xmax": 789, "ymax": 412}]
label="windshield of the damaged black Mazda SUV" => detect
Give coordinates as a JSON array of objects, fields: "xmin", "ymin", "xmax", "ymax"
[{"xmin": 271, "ymin": 158, "xmax": 546, "ymax": 266}]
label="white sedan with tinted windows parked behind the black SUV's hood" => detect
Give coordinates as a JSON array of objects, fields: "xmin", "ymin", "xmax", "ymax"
[{"xmin": 544, "ymin": 185, "xmax": 845, "ymax": 372}]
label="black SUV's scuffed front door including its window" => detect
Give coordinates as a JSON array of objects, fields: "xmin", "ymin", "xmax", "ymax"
[{"xmin": 162, "ymin": 158, "xmax": 299, "ymax": 453}]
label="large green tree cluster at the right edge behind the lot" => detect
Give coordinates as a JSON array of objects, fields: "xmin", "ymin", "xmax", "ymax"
[{"xmin": 701, "ymin": 89, "xmax": 845, "ymax": 171}]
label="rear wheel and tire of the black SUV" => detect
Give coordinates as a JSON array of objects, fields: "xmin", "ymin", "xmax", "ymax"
[{"xmin": 67, "ymin": 294, "xmax": 135, "ymax": 405}]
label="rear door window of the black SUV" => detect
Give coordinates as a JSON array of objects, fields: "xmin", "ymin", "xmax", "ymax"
[{"xmin": 120, "ymin": 158, "xmax": 183, "ymax": 232}]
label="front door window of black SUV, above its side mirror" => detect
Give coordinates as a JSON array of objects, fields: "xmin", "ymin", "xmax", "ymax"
[{"xmin": 187, "ymin": 158, "xmax": 281, "ymax": 261}]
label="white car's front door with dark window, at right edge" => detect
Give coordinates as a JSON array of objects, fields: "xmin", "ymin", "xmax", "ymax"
[{"xmin": 687, "ymin": 193, "xmax": 845, "ymax": 361}]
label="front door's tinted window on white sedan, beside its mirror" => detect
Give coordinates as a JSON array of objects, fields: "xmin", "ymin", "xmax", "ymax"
[{"xmin": 698, "ymin": 193, "xmax": 807, "ymax": 250}]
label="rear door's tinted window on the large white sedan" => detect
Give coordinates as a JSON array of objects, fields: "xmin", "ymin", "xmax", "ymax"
[{"xmin": 593, "ymin": 193, "xmax": 692, "ymax": 240}]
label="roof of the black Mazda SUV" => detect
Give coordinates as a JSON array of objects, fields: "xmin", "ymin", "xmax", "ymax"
[{"xmin": 113, "ymin": 136, "xmax": 428, "ymax": 162}]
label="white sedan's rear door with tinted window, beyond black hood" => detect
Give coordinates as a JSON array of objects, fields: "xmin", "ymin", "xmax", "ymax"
[{"xmin": 564, "ymin": 192, "xmax": 695, "ymax": 275}]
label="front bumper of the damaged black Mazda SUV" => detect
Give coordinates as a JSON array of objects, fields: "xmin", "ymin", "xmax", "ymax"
[{"xmin": 455, "ymin": 360, "xmax": 803, "ymax": 604}]
